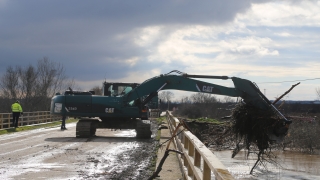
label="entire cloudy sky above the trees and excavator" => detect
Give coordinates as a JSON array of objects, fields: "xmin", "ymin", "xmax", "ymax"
[{"xmin": 0, "ymin": 0, "xmax": 320, "ymax": 100}]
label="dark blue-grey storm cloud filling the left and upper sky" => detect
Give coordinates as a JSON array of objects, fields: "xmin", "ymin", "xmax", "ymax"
[{"xmin": 0, "ymin": 0, "xmax": 268, "ymax": 80}]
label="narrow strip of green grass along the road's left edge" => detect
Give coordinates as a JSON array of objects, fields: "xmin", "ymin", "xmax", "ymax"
[{"xmin": 0, "ymin": 118, "xmax": 78, "ymax": 135}]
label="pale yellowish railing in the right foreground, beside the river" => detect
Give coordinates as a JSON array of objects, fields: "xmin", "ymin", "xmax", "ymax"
[{"xmin": 166, "ymin": 111, "xmax": 234, "ymax": 180}]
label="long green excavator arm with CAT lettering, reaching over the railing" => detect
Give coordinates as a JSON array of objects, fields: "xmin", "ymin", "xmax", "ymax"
[{"xmin": 125, "ymin": 71, "xmax": 291, "ymax": 123}]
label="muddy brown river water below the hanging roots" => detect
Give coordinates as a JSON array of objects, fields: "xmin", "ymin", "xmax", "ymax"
[{"xmin": 214, "ymin": 150, "xmax": 320, "ymax": 180}]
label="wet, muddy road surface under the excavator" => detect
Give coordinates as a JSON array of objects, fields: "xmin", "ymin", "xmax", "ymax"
[{"xmin": 0, "ymin": 123, "xmax": 156, "ymax": 180}]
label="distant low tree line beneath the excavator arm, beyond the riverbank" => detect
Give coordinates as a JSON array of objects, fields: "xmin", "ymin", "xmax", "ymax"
[{"xmin": 159, "ymin": 88, "xmax": 320, "ymax": 119}]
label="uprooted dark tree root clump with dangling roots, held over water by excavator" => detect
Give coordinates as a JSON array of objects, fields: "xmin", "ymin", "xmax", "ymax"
[{"xmin": 232, "ymin": 103, "xmax": 283, "ymax": 174}]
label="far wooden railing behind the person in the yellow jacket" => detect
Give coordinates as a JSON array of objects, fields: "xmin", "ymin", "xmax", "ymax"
[{"xmin": 0, "ymin": 111, "xmax": 61, "ymax": 129}]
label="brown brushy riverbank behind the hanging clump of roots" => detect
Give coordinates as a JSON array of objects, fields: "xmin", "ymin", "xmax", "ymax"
[{"xmin": 180, "ymin": 114, "xmax": 320, "ymax": 153}]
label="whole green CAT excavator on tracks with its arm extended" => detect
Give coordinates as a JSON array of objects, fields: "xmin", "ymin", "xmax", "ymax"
[{"xmin": 50, "ymin": 70, "xmax": 291, "ymax": 138}]
